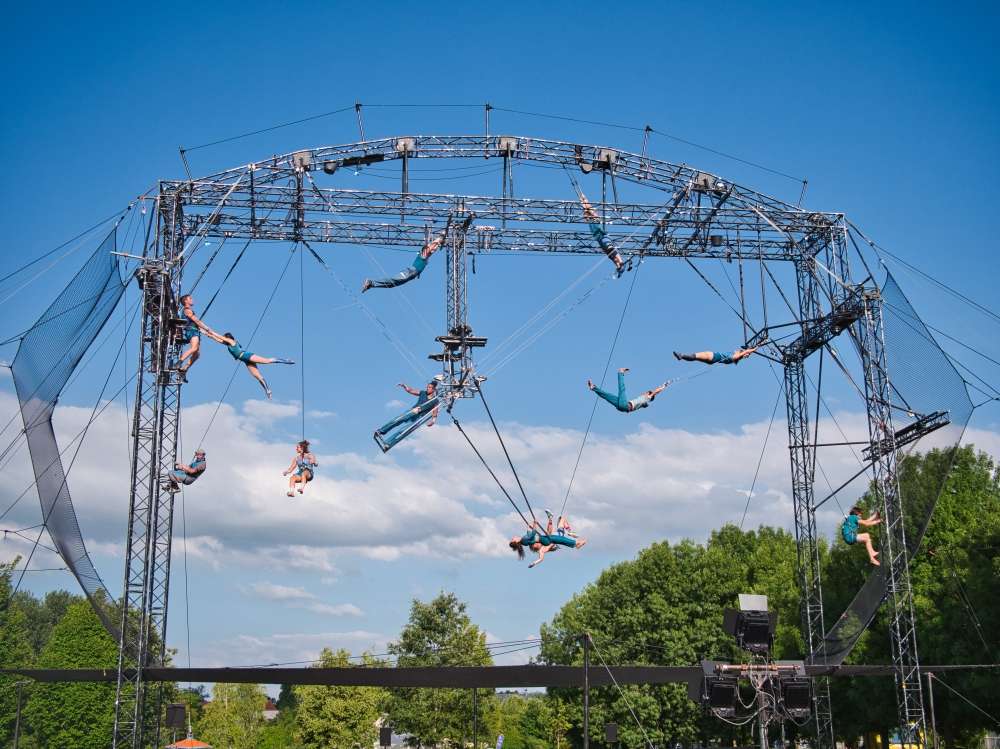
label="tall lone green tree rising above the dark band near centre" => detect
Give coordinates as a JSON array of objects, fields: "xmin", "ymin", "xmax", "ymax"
[{"xmin": 389, "ymin": 593, "xmax": 493, "ymax": 746}]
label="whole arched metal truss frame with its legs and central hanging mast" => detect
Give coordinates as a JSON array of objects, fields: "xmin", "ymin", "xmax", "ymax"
[{"xmin": 115, "ymin": 135, "xmax": 924, "ymax": 749}]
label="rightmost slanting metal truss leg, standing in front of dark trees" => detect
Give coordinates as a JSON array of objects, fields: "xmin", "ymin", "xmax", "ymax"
[{"xmin": 856, "ymin": 292, "xmax": 927, "ymax": 736}]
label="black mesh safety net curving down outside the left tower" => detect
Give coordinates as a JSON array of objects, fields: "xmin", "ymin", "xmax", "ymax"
[{"xmin": 11, "ymin": 230, "xmax": 125, "ymax": 633}]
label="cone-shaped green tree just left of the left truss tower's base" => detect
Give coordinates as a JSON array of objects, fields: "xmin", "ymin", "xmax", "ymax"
[{"xmin": 24, "ymin": 601, "xmax": 118, "ymax": 749}]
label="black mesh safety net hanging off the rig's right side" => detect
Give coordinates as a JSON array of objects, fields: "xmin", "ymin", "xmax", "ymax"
[{"xmin": 813, "ymin": 274, "xmax": 973, "ymax": 666}]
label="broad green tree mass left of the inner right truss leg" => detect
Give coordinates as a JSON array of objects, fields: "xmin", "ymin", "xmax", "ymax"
[{"xmin": 541, "ymin": 525, "xmax": 801, "ymax": 746}]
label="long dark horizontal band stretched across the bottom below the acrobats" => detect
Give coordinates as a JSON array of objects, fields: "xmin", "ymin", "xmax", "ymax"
[{"xmin": 0, "ymin": 664, "xmax": 1000, "ymax": 689}]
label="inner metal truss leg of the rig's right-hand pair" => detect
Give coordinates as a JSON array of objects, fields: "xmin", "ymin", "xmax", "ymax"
[{"xmin": 784, "ymin": 257, "xmax": 834, "ymax": 749}]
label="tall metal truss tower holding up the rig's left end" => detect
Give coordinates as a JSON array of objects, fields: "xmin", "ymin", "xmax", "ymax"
[{"xmin": 112, "ymin": 194, "xmax": 183, "ymax": 749}]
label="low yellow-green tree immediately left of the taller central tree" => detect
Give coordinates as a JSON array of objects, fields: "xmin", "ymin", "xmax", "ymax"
[{"xmin": 293, "ymin": 648, "xmax": 389, "ymax": 749}]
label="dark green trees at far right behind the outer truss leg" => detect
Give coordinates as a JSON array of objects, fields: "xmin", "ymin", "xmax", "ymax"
[{"xmin": 824, "ymin": 446, "xmax": 1000, "ymax": 747}]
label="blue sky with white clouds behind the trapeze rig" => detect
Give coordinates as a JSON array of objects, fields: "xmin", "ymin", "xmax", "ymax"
[{"xmin": 0, "ymin": 3, "xmax": 1000, "ymax": 676}]
